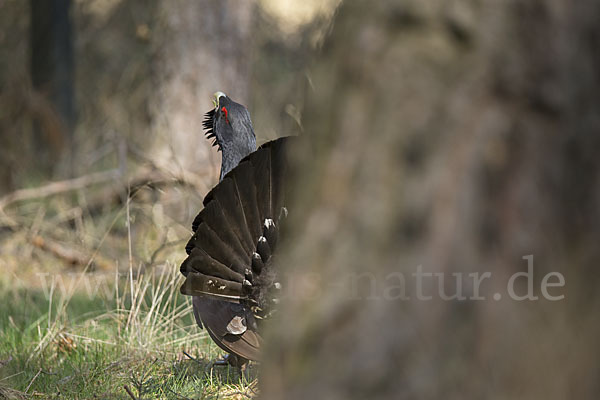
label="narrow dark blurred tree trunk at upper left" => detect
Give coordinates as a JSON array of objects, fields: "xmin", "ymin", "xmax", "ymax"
[{"xmin": 30, "ymin": 0, "xmax": 76, "ymax": 175}]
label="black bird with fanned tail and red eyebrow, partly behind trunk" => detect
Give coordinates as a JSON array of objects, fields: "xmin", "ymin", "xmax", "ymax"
[{"xmin": 181, "ymin": 92, "xmax": 292, "ymax": 367}]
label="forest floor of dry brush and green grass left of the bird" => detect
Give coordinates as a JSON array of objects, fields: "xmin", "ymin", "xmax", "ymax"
[{"xmin": 0, "ymin": 177, "xmax": 257, "ymax": 399}]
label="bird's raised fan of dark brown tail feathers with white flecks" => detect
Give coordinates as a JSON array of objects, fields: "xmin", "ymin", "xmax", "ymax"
[{"xmin": 181, "ymin": 138, "xmax": 289, "ymax": 304}]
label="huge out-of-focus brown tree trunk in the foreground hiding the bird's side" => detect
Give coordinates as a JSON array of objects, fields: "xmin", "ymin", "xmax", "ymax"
[{"xmin": 261, "ymin": 0, "xmax": 600, "ymax": 400}]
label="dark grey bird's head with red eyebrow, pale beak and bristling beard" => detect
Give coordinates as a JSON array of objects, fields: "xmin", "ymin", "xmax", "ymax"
[{"xmin": 203, "ymin": 92, "xmax": 256, "ymax": 158}]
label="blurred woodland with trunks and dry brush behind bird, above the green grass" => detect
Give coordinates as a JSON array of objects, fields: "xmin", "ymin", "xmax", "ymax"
[{"xmin": 0, "ymin": 0, "xmax": 338, "ymax": 288}]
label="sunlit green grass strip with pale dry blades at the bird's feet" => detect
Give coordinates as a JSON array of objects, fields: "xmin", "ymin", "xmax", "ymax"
[{"xmin": 0, "ymin": 265, "xmax": 255, "ymax": 399}]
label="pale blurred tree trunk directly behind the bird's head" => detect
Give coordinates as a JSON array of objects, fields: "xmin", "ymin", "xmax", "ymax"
[{"xmin": 152, "ymin": 0, "xmax": 254, "ymax": 172}]
